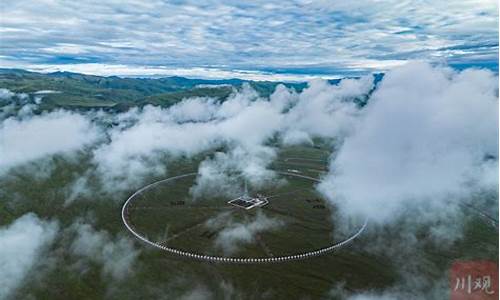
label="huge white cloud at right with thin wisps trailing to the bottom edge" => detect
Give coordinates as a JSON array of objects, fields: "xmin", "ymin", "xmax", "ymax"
[{"xmin": 318, "ymin": 62, "xmax": 498, "ymax": 300}]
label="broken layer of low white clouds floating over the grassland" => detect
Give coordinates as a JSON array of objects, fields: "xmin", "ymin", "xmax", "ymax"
[{"xmin": 0, "ymin": 62, "xmax": 498, "ymax": 299}]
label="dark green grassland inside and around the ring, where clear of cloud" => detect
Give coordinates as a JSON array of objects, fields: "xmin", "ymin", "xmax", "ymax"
[{"xmin": 0, "ymin": 144, "xmax": 498, "ymax": 299}]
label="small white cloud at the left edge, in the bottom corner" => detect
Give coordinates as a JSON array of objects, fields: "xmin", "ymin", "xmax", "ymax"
[{"xmin": 0, "ymin": 213, "xmax": 58, "ymax": 299}]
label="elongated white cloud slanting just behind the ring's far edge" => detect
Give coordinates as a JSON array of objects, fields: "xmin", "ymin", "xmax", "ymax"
[{"xmin": 93, "ymin": 87, "xmax": 279, "ymax": 187}]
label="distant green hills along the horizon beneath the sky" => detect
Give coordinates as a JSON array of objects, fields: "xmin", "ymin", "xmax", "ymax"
[{"xmin": 0, "ymin": 69, "xmax": 383, "ymax": 111}]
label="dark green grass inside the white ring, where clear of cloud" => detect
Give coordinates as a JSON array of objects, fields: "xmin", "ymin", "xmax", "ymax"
[{"xmin": 128, "ymin": 176, "xmax": 333, "ymax": 257}]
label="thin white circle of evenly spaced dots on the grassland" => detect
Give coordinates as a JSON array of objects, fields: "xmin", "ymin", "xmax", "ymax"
[{"xmin": 122, "ymin": 171, "xmax": 368, "ymax": 264}]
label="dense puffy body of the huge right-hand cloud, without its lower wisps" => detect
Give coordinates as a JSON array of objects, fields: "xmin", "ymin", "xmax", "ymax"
[{"xmin": 319, "ymin": 63, "xmax": 498, "ymax": 222}]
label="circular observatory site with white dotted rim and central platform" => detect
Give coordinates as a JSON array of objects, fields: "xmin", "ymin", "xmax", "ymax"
[{"xmin": 122, "ymin": 171, "xmax": 366, "ymax": 264}]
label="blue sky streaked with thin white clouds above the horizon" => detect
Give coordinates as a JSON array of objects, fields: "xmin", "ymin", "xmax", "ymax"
[{"xmin": 0, "ymin": 0, "xmax": 498, "ymax": 80}]
